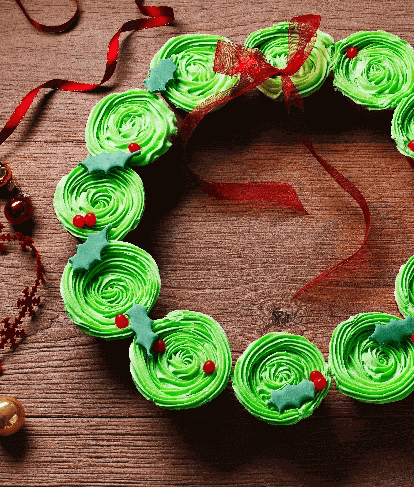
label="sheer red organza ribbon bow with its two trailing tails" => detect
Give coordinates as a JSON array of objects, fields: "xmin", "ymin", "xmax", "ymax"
[{"xmin": 181, "ymin": 15, "xmax": 370, "ymax": 299}]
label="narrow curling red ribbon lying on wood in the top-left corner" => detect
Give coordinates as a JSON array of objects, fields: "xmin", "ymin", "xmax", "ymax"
[{"xmin": 0, "ymin": 0, "xmax": 174, "ymax": 148}]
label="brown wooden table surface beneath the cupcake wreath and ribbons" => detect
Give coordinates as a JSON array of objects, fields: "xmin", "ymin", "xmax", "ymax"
[{"xmin": 0, "ymin": 0, "xmax": 414, "ymax": 487}]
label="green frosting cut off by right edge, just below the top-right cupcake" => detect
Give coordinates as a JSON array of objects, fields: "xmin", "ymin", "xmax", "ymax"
[{"xmin": 391, "ymin": 93, "xmax": 414, "ymax": 159}]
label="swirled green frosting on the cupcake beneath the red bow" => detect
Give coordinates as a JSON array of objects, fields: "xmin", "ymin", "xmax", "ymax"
[{"xmin": 245, "ymin": 22, "xmax": 334, "ymax": 99}]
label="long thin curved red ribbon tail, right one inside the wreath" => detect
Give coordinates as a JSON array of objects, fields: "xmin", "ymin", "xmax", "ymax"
[{"xmin": 291, "ymin": 138, "xmax": 371, "ymax": 299}]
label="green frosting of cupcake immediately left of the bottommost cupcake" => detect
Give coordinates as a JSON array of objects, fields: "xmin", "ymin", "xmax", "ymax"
[{"xmin": 129, "ymin": 311, "xmax": 231, "ymax": 409}]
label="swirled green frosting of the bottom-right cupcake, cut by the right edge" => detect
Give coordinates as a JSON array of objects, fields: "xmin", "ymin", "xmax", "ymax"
[{"xmin": 329, "ymin": 313, "xmax": 414, "ymax": 403}]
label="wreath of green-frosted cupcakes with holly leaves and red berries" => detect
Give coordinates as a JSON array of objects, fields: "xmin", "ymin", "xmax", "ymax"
[{"xmin": 54, "ymin": 16, "xmax": 414, "ymax": 425}]
